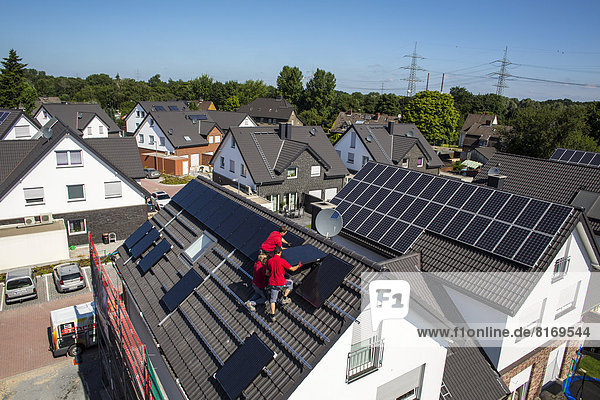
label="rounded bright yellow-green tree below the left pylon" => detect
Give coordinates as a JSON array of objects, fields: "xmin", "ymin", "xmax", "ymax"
[{"xmin": 402, "ymin": 91, "xmax": 460, "ymax": 145}]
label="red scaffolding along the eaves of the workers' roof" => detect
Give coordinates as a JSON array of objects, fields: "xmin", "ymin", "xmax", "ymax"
[{"xmin": 88, "ymin": 234, "xmax": 164, "ymax": 400}]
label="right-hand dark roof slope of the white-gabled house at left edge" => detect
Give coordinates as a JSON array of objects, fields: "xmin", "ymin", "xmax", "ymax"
[{"xmin": 86, "ymin": 137, "xmax": 146, "ymax": 179}]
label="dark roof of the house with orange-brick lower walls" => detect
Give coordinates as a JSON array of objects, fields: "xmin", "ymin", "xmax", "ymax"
[{"xmin": 146, "ymin": 111, "xmax": 218, "ymax": 148}]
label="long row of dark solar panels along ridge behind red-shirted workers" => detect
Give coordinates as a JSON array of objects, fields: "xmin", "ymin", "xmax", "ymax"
[{"xmin": 171, "ymin": 180, "xmax": 303, "ymax": 259}]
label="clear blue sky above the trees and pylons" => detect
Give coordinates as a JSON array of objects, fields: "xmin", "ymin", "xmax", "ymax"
[{"xmin": 0, "ymin": 0, "xmax": 600, "ymax": 101}]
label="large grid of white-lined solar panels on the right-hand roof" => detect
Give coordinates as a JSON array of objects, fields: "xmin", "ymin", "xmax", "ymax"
[{"xmin": 332, "ymin": 162, "xmax": 572, "ymax": 267}]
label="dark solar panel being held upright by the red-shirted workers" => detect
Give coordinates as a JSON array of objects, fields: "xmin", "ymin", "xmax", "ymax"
[{"xmin": 296, "ymin": 254, "xmax": 354, "ymax": 308}]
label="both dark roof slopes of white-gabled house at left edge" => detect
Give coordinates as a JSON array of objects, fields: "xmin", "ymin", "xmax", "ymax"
[{"xmin": 0, "ymin": 122, "xmax": 150, "ymax": 202}]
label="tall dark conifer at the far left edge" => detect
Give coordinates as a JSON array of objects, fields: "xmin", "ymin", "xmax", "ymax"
[{"xmin": 0, "ymin": 49, "xmax": 35, "ymax": 108}]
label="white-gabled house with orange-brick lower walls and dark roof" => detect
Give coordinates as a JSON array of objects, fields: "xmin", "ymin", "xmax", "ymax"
[{"xmin": 134, "ymin": 110, "xmax": 256, "ymax": 175}]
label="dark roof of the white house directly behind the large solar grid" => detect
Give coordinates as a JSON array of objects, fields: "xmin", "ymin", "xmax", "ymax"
[{"xmin": 346, "ymin": 124, "xmax": 444, "ymax": 168}]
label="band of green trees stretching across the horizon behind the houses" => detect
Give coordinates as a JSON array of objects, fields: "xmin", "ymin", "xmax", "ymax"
[{"xmin": 0, "ymin": 50, "xmax": 600, "ymax": 157}]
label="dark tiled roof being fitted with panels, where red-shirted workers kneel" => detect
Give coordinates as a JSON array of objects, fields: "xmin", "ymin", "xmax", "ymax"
[{"xmin": 117, "ymin": 178, "xmax": 505, "ymax": 400}]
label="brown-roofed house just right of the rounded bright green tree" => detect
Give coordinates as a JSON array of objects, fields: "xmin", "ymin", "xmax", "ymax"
[{"xmin": 458, "ymin": 114, "xmax": 511, "ymax": 155}]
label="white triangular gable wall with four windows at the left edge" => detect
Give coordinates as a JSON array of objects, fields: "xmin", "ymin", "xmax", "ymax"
[{"xmin": 0, "ymin": 136, "xmax": 145, "ymax": 220}]
